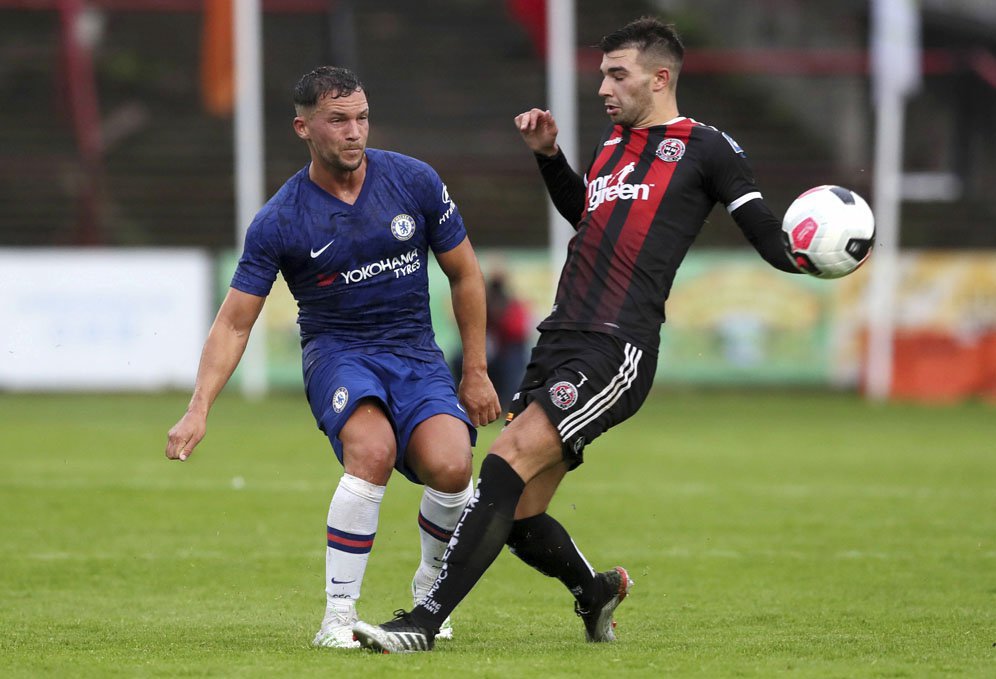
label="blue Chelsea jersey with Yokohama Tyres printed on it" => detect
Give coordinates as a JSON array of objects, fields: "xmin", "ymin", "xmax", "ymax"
[{"xmin": 232, "ymin": 149, "xmax": 467, "ymax": 364}]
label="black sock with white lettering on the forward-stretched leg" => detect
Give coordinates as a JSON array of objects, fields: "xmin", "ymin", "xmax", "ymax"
[{"xmin": 412, "ymin": 454, "xmax": 525, "ymax": 630}]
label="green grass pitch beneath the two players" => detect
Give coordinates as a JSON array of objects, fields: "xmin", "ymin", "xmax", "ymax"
[{"xmin": 0, "ymin": 391, "xmax": 996, "ymax": 677}]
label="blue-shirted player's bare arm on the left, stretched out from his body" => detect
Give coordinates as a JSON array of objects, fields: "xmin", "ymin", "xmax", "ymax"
[{"xmin": 166, "ymin": 288, "xmax": 266, "ymax": 461}]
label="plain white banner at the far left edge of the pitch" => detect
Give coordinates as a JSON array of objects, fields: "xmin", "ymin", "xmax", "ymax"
[{"xmin": 0, "ymin": 248, "xmax": 214, "ymax": 391}]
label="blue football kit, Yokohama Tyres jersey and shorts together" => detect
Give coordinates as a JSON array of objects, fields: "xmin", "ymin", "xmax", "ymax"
[{"xmin": 231, "ymin": 149, "xmax": 476, "ymax": 482}]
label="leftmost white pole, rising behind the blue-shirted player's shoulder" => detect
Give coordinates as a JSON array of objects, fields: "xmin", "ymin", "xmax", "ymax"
[{"xmin": 232, "ymin": 0, "xmax": 268, "ymax": 398}]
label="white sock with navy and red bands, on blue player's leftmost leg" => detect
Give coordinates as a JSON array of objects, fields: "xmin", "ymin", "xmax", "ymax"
[{"xmin": 325, "ymin": 474, "xmax": 387, "ymax": 620}]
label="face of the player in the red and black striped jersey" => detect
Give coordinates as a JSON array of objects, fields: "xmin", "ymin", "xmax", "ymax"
[{"xmin": 598, "ymin": 48, "xmax": 654, "ymax": 127}]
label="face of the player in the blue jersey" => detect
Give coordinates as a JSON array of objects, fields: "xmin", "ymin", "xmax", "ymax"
[{"xmin": 294, "ymin": 90, "xmax": 370, "ymax": 174}]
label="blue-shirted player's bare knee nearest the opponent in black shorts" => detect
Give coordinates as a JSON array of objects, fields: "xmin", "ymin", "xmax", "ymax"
[{"xmin": 405, "ymin": 414, "xmax": 473, "ymax": 493}]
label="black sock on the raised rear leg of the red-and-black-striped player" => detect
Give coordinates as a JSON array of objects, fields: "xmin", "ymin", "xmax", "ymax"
[{"xmin": 508, "ymin": 513, "xmax": 597, "ymax": 607}]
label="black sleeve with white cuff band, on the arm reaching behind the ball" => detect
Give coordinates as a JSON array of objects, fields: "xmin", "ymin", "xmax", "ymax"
[{"xmin": 708, "ymin": 132, "xmax": 799, "ymax": 273}]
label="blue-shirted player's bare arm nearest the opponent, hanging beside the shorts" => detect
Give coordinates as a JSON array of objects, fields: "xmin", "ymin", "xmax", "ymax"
[{"xmin": 436, "ymin": 238, "xmax": 501, "ymax": 427}]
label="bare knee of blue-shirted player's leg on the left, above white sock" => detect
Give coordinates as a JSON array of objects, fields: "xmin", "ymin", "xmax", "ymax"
[{"xmin": 339, "ymin": 398, "xmax": 397, "ymax": 486}]
